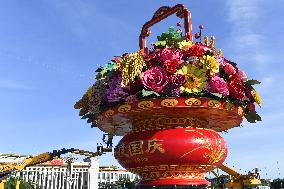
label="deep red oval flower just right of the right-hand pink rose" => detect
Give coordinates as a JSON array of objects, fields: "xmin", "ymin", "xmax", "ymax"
[{"xmin": 228, "ymin": 75, "xmax": 245, "ymax": 100}]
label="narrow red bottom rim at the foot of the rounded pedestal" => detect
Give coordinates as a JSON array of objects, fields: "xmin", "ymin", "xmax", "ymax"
[{"xmin": 138, "ymin": 178, "xmax": 209, "ymax": 187}]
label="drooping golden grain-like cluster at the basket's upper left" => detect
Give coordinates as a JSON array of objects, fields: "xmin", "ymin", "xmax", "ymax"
[{"xmin": 120, "ymin": 51, "xmax": 146, "ymax": 87}]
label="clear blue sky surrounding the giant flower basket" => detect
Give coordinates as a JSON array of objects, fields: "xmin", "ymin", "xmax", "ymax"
[{"xmin": 0, "ymin": 0, "xmax": 284, "ymax": 177}]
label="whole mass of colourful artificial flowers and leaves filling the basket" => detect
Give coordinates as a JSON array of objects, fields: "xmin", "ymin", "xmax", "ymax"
[{"xmin": 75, "ymin": 24, "xmax": 261, "ymax": 129}]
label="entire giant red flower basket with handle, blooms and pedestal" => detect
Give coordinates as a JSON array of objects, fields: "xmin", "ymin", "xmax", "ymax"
[{"xmin": 75, "ymin": 4, "xmax": 261, "ymax": 188}]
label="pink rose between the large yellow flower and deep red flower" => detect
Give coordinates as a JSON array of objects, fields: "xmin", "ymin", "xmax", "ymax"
[{"xmin": 209, "ymin": 76, "xmax": 229, "ymax": 96}]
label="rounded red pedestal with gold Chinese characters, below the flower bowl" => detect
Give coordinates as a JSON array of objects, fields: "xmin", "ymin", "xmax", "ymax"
[{"xmin": 115, "ymin": 128, "xmax": 227, "ymax": 186}]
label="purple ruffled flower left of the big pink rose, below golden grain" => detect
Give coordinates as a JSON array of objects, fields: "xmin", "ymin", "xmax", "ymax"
[{"xmin": 106, "ymin": 75, "xmax": 128, "ymax": 102}]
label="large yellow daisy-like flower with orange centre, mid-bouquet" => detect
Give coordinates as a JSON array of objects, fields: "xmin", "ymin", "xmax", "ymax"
[{"xmin": 178, "ymin": 64, "xmax": 207, "ymax": 93}]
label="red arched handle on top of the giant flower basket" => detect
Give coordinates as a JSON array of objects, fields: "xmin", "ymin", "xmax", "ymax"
[{"xmin": 139, "ymin": 4, "xmax": 193, "ymax": 52}]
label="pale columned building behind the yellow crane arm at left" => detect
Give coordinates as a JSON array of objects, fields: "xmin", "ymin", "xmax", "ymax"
[{"xmin": 0, "ymin": 156, "xmax": 138, "ymax": 189}]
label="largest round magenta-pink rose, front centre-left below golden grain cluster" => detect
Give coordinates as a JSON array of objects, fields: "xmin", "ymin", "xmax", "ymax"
[{"xmin": 141, "ymin": 66, "xmax": 169, "ymax": 93}]
